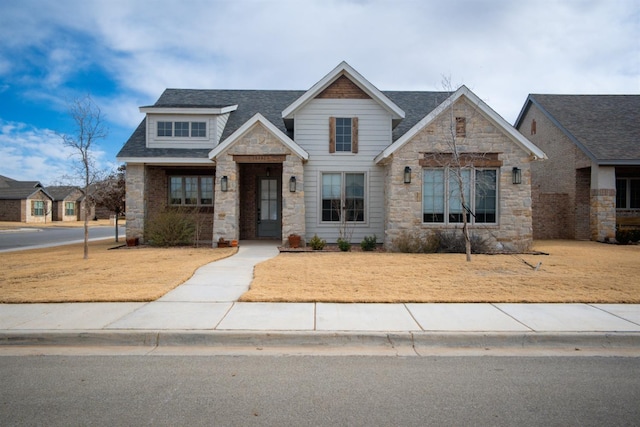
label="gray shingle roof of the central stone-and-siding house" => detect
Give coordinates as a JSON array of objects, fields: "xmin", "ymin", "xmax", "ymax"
[{"xmin": 118, "ymin": 89, "xmax": 451, "ymax": 158}]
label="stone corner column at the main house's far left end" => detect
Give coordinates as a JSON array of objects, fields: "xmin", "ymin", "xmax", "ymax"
[{"xmin": 125, "ymin": 163, "xmax": 145, "ymax": 242}]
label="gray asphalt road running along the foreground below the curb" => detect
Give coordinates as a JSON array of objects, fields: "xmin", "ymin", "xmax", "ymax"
[{"xmin": 0, "ymin": 356, "xmax": 640, "ymax": 426}]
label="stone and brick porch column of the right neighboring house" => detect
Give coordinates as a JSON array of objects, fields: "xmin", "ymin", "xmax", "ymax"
[{"xmin": 589, "ymin": 164, "xmax": 616, "ymax": 242}]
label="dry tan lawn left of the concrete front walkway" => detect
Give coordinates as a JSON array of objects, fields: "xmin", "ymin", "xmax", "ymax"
[{"xmin": 0, "ymin": 240, "xmax": 237, "ymax": 303}]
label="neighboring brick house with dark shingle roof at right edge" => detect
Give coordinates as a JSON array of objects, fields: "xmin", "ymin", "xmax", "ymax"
[{"xmin": 515, "ymin": 94, "xmax": 640, "ymax": 241}]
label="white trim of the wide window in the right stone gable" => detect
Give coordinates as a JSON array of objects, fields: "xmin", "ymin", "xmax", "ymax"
[{"xmin": 420, "ymin": 166, "xmax": 501, "ymax": 228}]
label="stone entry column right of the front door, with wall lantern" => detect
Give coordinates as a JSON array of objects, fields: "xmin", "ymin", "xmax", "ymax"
[{"xmin": 282, "ymin": 154, "xmax": 306, "ymax": 244}]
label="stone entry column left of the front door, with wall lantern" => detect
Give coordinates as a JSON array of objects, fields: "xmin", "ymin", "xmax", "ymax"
[{"xmin": 213, "ymin": 154, "xmax": 240, "ymax": 247}]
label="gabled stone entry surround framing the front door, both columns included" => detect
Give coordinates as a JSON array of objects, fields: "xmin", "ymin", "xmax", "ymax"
[{"xmin": 213, "ymin": 123, "xmax": 305, "ymax": 246}]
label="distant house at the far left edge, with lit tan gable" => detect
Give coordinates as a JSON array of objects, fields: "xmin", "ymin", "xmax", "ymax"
[{"xmin": 0, "ymin": 175, "xmax": 53, "ymax": 223}]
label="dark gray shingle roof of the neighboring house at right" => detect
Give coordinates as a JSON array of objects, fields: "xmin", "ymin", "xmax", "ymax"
[{"xmin": 515, "ymin": 94, "xmax": 640, "ymax": 165}]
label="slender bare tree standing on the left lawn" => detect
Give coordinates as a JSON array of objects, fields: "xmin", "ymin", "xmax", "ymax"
[{"xmin": 61, "ymin": 95, "xmax": 108, "ymax": 259}]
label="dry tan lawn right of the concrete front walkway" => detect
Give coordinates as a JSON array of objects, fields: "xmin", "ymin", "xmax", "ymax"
[{"xmin": 240, "ymin": 241, "xmax": 640, "ymax": 303}]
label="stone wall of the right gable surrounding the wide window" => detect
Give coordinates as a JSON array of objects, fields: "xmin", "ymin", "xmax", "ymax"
[{"xmin": 385, "ymin": 100, "xmax": 533, "ymax": 250}]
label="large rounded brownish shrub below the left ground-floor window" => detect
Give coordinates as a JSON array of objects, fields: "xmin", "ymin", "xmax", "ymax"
[{"xmin": 145, "ymin": 209, "xmax": 196, "ymax": 246}]
